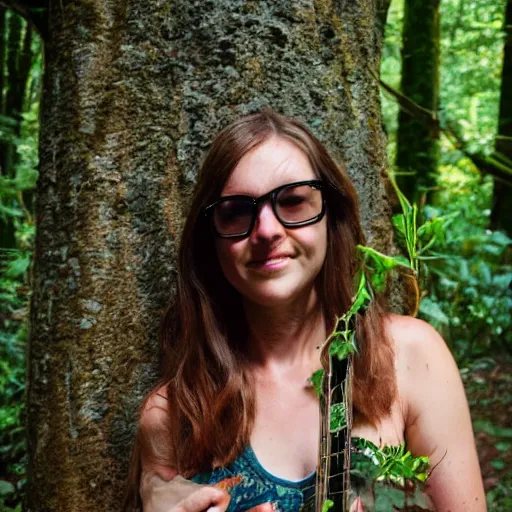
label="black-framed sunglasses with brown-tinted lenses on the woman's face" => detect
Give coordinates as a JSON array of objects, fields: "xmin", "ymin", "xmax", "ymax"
[{"xmin": 203, "ymin": 180, "xmax": 325, "ymax": 238}]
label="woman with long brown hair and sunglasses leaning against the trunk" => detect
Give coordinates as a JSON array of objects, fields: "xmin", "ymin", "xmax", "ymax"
[{"xmin": 126, "ymin": 111, "xmax": 485, "ymax": 512}]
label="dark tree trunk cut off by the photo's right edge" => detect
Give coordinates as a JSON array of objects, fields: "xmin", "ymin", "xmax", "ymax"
[{"xmin": 491, "ymin": 0, "xmax": 512, "ymax": 236}]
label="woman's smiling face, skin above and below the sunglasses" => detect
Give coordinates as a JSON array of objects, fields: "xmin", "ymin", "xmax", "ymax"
[{"xmin": 216, "ymin": 136, "xmax": 327, "ymax": 306}]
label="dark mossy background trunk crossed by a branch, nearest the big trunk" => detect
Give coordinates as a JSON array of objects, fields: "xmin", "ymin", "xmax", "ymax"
[{"xmin": 396, "ymin": 0, "xmax": 439, "ymax": 201}]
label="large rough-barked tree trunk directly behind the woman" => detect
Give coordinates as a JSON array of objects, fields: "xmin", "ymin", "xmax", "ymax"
[{"xmin": 28, "ymin": 0, "xmax": 392, "ymax": 512}]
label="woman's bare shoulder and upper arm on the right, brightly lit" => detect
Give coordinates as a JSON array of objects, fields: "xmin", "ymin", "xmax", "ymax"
[{"xmin": 391, "ymin": 316, "xmax": 487, "ymax": 512}]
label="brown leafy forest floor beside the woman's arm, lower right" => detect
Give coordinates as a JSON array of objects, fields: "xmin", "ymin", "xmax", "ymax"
[{"xmin": 461, "ymin": 356, "xmax": 512, "ymax": 512}]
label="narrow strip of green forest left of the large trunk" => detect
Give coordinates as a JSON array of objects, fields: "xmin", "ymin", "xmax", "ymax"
[{"xmin": 0, "ymin": 4, "xmax": 43, "ymax": 510}]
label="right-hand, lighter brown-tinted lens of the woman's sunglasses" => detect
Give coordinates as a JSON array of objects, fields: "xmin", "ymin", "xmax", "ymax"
[{"xmin": 276, "ymin": 185, "xmax": 323, "ymax": 224}]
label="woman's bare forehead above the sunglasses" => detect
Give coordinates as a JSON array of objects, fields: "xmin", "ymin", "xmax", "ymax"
[{"xmin": 222, "ymin": 137, "xmax": 317, "ymax": 197}]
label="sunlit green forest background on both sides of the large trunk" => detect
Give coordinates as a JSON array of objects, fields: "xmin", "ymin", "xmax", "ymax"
[{"xmin": 0, "ymin": 0, "xmax": 512, "ymax": 512}]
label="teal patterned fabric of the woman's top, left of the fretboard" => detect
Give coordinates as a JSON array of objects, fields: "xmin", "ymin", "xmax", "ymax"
[{"xmin": 192, "ymin": 447, "xmax": 316, "ymax": 512}]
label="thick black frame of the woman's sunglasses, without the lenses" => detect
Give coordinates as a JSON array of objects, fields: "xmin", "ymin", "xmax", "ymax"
[{"xmin": 203, "ymin": 180, "xmax": 326, "ymax": 238}]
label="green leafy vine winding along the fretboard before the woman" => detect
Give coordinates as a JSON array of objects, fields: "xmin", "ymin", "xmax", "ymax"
[{"xmin": 310, "ymin": 176, "xmax": 453, "ymax": 512}]
